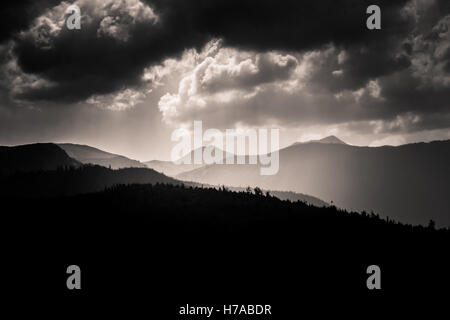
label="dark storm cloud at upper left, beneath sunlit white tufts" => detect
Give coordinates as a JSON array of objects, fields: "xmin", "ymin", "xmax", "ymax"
[{"xmin": 10, "ymin": 1, "xmax": 207, "ymax": 102}]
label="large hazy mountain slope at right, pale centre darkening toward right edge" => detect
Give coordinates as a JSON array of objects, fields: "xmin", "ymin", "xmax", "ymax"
[{"xmin": 177, "ymin": 141, "xmax": 450, "ymax": 225}]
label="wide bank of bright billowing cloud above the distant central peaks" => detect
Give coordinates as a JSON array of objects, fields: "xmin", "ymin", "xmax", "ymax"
[{"xmin": 158, "ymin": 42, "xmax": 382, "ymax": 127}]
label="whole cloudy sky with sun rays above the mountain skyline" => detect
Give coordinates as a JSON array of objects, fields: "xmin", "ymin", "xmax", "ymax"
[{"xmin": 0, "ymin": 0, "xmax": 450, "ymax": 161}]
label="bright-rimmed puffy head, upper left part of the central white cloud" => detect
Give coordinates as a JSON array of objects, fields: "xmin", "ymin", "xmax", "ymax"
[{"xmin": 159, "ymin": 42, "xmax": 301, "ymax": 124}]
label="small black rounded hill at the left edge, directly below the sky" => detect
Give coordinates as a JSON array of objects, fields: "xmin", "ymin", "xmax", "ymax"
[{"xmin": 0, "ymin": 143, "xmax": 80, "ymax": 174}]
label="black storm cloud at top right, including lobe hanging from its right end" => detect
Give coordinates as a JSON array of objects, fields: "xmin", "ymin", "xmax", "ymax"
[{"xmin": 153, "ymin": 0, "xmax": 414, "ymax": 90}]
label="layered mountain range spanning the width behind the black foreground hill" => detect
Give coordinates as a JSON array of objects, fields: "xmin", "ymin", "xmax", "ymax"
[{"xmin": 0, "ymin": 136, "xmax": 450, "ymax": 226}]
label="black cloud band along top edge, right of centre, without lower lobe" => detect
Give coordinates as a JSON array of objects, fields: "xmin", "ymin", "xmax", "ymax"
[{"xmin": 149, "ymin": 0, "xmax": 409, "ymax": 51}]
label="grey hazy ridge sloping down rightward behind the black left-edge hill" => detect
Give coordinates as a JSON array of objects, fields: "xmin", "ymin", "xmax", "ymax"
[{"xmin": 58, "ymin": 143, "xmax": 147, "ymax": 169}]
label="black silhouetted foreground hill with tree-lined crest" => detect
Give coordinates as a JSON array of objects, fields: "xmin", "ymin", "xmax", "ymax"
[{"xmin": 4, "ymin": 184, "xmax": 450, "ymax": 298}]
